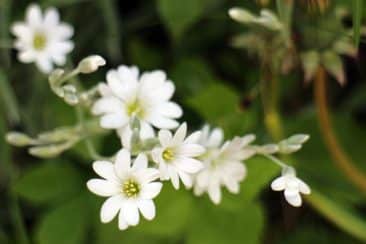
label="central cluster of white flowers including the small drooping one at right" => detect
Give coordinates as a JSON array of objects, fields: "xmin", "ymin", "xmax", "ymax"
[{"xmin": 84, "ymin": 65, "xmax": 310, "ymax": 229}]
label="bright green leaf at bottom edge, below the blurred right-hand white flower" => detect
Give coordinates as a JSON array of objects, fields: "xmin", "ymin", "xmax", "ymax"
[{"xmin": 186, "ymin": 202, "xmax": 264, "ymax": 244}]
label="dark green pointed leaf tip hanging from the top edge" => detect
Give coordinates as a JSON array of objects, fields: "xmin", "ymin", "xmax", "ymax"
[{"xmin": 157, "ymin": 0, "xmax": 208, "ymax": 39}]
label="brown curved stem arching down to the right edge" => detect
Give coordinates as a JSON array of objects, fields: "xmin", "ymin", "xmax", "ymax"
[{"xmin": 314, "ymin": 67, "xmax": 366, "ymax": 193}]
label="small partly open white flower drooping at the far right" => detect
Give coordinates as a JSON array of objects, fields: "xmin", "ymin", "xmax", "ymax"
[{"xmin": 271, "ymin": 167, "xmax": 311, "ymax": 207}]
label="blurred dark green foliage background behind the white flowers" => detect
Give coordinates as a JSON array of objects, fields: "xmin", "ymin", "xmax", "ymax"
[{"xmin": 0, "ymin": 0, "xmax": 366, "ymax": 244}]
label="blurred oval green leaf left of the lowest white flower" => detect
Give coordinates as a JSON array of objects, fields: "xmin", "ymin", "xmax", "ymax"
[{"xmin": 14, "ymin": 161, "xmax": 85, "ymax": 204}]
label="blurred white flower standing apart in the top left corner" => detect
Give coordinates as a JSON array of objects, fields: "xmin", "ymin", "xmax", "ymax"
[{"xmin": 11, "ymin": 4, "xmax": 74, "ymax": 73}]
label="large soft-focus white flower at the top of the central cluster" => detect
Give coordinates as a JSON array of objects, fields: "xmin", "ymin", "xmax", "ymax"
[{"xmin": 92, "ymin": 65, "xmax": 182, "ymax": 134}]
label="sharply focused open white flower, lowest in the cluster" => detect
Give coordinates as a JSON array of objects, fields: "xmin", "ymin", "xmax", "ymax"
[{"xmin": 87, "ymin": 149, "xmax": 162, "ymax": 230}]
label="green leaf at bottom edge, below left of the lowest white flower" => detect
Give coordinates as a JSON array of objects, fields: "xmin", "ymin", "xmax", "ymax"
[{"xmin": 35, "ymin": 195, "xmax": 89, "ymax": 244}]
